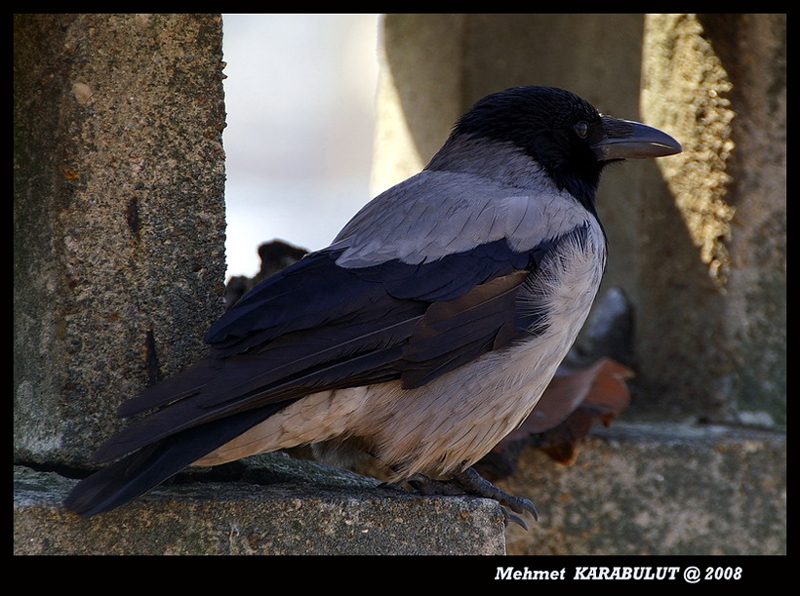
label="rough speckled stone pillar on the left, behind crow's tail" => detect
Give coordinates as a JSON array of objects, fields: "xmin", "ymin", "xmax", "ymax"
[{"xmin": 14, "ymin": 14, "xmax": 225, "ymax": 465}]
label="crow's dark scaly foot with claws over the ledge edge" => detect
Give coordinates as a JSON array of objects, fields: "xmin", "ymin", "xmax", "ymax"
[{"xmin": 407, "ymin": 468, "xmax": 539, "ymax": 530}]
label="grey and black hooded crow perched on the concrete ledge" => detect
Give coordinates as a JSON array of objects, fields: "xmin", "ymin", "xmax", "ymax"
[{"xmin": 64, "ymin": 85, "xmax": 682, "ymax": 526}]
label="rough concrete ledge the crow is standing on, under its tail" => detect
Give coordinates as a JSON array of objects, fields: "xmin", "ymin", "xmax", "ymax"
[{"xmin": 14, "ymin": 461, "xmax": 505, "ymax": 555}]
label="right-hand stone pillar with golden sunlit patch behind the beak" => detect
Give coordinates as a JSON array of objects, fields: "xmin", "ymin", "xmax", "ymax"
[{"xmin": 638, "ymin": 14, "xmax": 786, "ymax": 426}]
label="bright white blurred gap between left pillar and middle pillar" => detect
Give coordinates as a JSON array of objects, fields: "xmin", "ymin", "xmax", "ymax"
[{"xmin": 223, "ymin": 14, "xmax": 378, "ymax": 277}]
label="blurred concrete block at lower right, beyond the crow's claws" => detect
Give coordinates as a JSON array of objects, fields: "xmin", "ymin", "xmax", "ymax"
[{"xmin": 497, "ymin": 421, "xmax": 786, "ymax": 555}]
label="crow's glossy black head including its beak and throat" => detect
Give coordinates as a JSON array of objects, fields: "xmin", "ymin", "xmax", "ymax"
[{"xmin": 444, "ymin": 86, "xmax": 681, "ymax": 208}]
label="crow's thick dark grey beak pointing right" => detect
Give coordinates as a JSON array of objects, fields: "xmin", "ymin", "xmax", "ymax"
[{"xmin": 592, "ymin": 116, "xmax": 683, "ymax": 161}]
